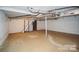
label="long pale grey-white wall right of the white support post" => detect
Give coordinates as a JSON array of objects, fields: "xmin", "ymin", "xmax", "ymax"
[{"xmin": 48, "ymin": 16, "xmax": 79, "ymax": 34}]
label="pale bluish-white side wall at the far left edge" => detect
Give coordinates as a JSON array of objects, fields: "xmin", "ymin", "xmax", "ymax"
[{"xmin": 0, "ymin": 11, "xmax": 8, "ymax": 45}]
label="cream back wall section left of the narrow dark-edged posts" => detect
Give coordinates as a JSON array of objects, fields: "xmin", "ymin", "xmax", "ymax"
[{"xmin": 9, "ymin": 18, "xmax": 24, "ymax": 33}]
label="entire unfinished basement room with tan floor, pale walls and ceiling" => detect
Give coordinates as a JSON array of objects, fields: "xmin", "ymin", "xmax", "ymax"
[{"xmin": 0, "ymin": 6, "xmax": 79, "ymax": 52}]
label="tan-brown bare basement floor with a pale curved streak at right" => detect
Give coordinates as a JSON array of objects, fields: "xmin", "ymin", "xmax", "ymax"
[{"xmin": 2, "ymin": 31, "xmax": 79, "ymax": 52}]
